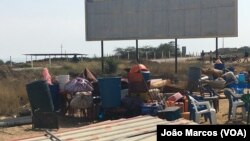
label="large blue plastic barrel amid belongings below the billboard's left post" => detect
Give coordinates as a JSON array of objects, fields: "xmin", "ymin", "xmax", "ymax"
[{"xmin": 98, "ymin": 77, "xmax": 121, "ymax": 108}]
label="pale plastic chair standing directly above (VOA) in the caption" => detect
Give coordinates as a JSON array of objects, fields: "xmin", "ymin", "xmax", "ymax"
[{"xmin": 224, "ymin": 88, "xmax": 246, "ymax": 120}]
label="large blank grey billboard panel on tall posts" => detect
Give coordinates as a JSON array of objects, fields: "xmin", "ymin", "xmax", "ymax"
[{"xmin": 85, "ymin": 0, "xmax": 238, "ymax": 41}]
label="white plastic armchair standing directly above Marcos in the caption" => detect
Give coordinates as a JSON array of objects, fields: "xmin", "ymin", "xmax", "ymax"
[{"xmin": 188, "ymin": 95, "xmax": 217, "ymax": 124}]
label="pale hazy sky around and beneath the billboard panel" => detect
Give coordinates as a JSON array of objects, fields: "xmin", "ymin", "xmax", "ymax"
[{"xmin": 0, "ymin": 0, "xmax": 250, "ymax": 62}]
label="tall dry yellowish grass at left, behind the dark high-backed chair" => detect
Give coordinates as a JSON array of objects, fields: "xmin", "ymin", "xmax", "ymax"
[{"xmin": 0, "ymin": 60, "xmax": 101, "ymax": 116}]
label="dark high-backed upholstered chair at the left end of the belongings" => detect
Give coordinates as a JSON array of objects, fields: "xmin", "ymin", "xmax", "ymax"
[{"xmin": 26, "ymin": 80, "xmax": 59, "ymax": 129}]
